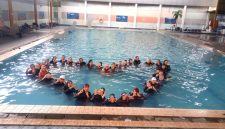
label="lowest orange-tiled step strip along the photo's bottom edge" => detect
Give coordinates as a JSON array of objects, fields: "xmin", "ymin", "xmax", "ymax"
[{"xmin": 0, "ymin": 118, "xmax": 225, "ymax": 129}]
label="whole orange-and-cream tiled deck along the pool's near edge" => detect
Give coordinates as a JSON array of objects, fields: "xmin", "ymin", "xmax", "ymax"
[{"xmin": 0, "ymin": 105, "xmax": 225, "ymax": 129}]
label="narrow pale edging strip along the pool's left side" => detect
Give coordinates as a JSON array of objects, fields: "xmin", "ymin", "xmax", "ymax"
[{"xmin": 0, "ymin": 30, "xmax": 65, "ymax": 61}]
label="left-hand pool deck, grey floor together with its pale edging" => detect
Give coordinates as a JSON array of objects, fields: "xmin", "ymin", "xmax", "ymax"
[{"xmin": 0, "ymin": 26, "xmax": 68, "ymax": 61}]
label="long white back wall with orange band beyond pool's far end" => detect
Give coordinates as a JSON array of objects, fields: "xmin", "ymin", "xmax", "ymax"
[{"xmin": 59, "ymin": 1, "xmax": 214, "ymax": 29}]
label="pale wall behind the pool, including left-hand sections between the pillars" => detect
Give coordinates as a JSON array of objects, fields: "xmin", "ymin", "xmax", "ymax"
[{"xmin": 0, "ymin": 0, "xmax": 215, "ymax": 29}]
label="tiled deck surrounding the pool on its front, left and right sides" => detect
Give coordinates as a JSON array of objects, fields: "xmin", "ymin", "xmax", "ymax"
[{"xmin": 0, "ymin": 27, "xmax": 225, "ymax": 129}]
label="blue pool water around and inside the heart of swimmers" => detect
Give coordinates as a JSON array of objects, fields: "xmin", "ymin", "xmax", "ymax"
[{"xmin": 0, "ymin": 29, "xmax": 225, "ymax": 109}]
